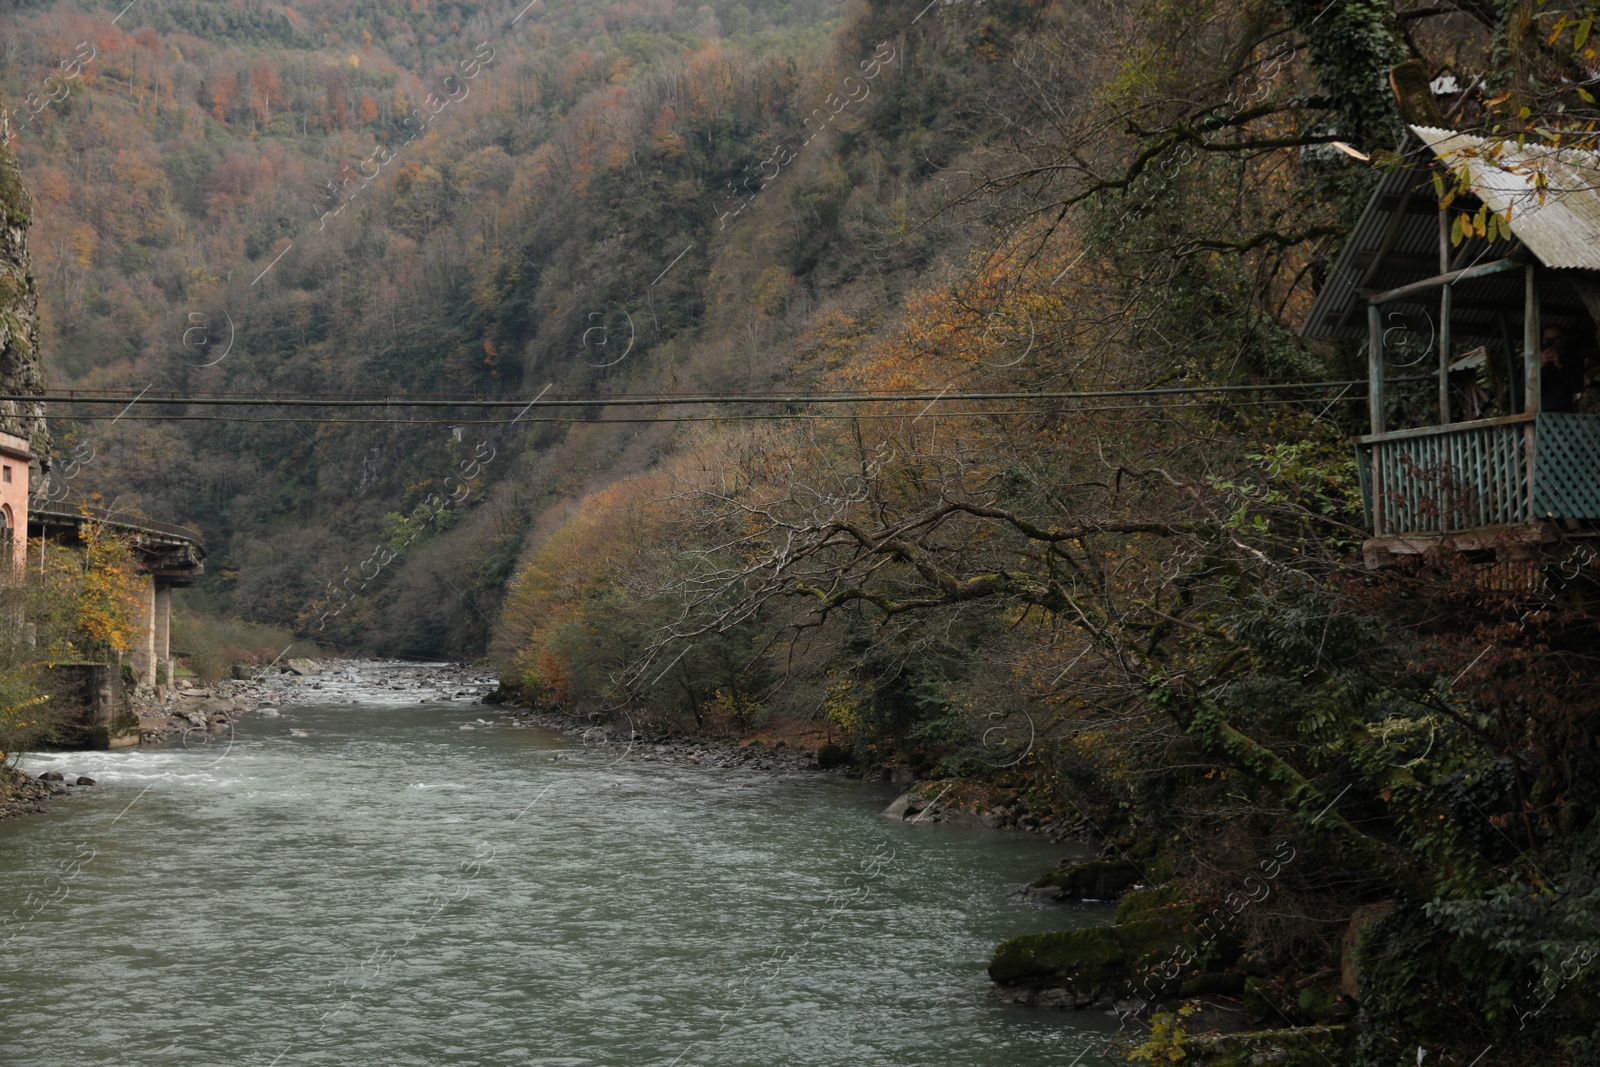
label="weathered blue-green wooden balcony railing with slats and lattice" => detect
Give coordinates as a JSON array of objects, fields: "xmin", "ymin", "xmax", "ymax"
[{"xmin": 1355, "ymin": 413, "xmax": 1600, "ymax": 537}]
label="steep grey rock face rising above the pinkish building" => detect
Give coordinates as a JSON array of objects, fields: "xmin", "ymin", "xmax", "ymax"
[{"xmin": 0, "ymin": 109, "xmax": 50, "ymax": 463}]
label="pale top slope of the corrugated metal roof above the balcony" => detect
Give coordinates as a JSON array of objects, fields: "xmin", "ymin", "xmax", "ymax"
[{"xmin": 1411, "ymin": 126, "xmax": 1600, "ymax": 270}]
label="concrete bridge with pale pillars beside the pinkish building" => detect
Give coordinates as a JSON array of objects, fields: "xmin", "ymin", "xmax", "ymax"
[{"xmin": 27, "ymin": 507, "xmax": 205, "ymax": 688}]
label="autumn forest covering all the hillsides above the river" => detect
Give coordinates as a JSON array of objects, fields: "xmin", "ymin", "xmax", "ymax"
[{"xmin": 0, "ymin": 0, "xmax": 1600, "ymax": 1067}]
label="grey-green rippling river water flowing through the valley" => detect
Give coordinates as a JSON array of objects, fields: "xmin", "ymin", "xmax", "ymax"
[{"xmin": 0, "ymin": 668, "xmax": 1115, "ymax": 1067}]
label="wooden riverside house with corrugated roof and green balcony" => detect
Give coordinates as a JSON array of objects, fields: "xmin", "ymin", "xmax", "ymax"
[{"xmin": 1302, "ymin": 126, "xmax": 1600, "ymax": 568}]
